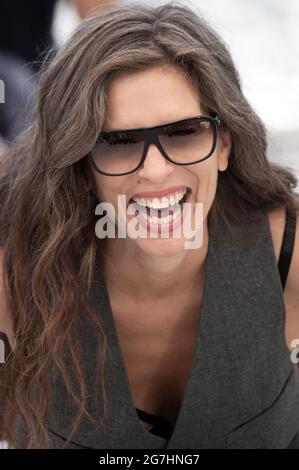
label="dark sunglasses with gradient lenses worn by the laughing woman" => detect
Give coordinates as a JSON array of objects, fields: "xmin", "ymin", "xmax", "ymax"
[{"xmin": 87, "ymin": 115, "xmax": 221, "ymax": 176}]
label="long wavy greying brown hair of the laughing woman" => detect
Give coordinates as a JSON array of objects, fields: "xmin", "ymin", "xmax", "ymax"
[{"xmin": 0, "ymin": 2, "xmax": 297, "ymax": 448}]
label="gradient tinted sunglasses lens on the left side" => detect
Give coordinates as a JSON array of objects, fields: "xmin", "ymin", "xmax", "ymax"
[{"xmin": 91, "ymin": 131, "xmax": 144, "ymax": 174}]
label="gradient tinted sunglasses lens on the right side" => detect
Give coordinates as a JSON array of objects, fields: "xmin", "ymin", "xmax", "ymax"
[{"xmin": 158, "ymin": 119, "xmax": 214, "ymax": 163}]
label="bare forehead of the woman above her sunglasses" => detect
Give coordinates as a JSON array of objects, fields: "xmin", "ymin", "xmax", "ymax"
[{"xmin": 105, "ymin": 66, "xmax": 202, "ymax": 130}]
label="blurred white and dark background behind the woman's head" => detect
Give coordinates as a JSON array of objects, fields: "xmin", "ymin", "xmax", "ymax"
[{"xmin": 0, "ymin": 0, "xmax": 299, "ymax": 185}]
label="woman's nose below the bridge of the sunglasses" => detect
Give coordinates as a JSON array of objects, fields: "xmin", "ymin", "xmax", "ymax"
[{"xmin": 138, "ymin": 144, "xmax": 175, "ymax": 181}]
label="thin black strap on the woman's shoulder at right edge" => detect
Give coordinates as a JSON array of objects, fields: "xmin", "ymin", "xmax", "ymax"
[{"xmin": 278, "ymin": 209, "xmax": 296, "ymax": 290}]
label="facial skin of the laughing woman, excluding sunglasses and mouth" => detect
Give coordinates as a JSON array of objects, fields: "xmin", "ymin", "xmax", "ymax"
[{"xmin": 93, "ymin": 66, "xmax": 231, "ymax": 302}]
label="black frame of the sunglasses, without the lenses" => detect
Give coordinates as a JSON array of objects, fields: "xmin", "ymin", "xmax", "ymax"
[{"xmin": 87, "ymin": 115, "xmax": 221, "ymax": 176}]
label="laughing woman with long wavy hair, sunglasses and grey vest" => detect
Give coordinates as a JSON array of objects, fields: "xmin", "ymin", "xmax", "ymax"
[{"xmin": 0, "ymin": 3, "xmax": 299, "ymax": 449}]
